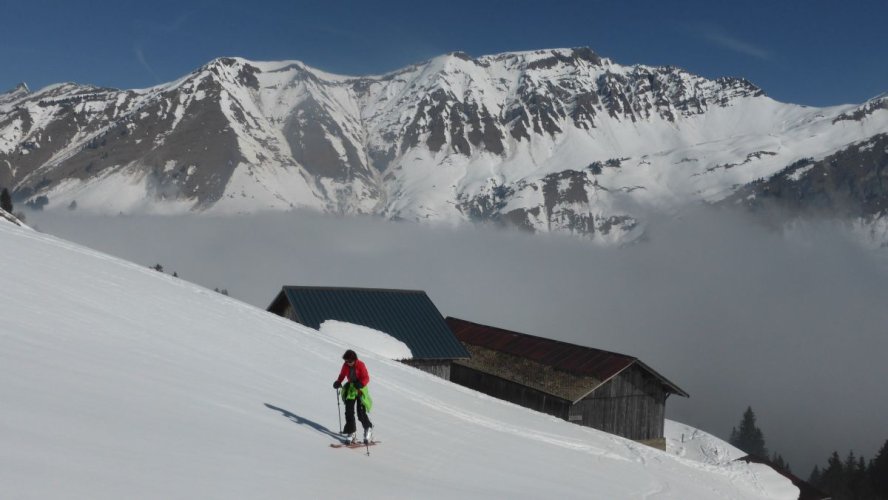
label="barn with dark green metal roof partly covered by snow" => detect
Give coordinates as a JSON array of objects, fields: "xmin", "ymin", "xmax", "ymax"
[{"xmin": 268, "ymin": 286, "xmax": 469, "ymax": 380}]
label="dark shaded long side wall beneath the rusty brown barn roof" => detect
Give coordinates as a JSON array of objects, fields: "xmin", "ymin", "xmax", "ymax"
[{"xmin": 450, "ymin": 362, "xmax": 570, "ymax": 419}]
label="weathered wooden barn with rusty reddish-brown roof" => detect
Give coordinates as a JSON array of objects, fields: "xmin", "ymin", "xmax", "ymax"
[{"xmin": 446, "ymin": 318, "xmax": 688, "ymax": 448}]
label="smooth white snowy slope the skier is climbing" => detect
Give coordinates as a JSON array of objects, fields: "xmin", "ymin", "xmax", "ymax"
[{"xmin": 0, "ymin": 221, "xmax": 797, "ymax": 499}]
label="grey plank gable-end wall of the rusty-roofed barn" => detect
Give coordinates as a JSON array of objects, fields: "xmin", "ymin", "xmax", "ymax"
[{"xmin": 568, "ymin": 366, "xmax": 668, "ymax": 440}]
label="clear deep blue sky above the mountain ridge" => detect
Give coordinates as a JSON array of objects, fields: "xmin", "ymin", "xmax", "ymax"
[{"xmin": 0, "ymin": 0, "xmax": 888, "ymax": 106}]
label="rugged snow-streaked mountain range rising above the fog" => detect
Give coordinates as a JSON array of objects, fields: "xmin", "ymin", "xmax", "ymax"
[{"xmin": 0, "ymin": 48, "xmax": 888, "ymax": 240}]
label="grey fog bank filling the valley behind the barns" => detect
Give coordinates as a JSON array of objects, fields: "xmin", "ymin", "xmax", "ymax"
[{"xmin": 27, "ymin": 210, "xmax": 888, "ymax": 478}]
